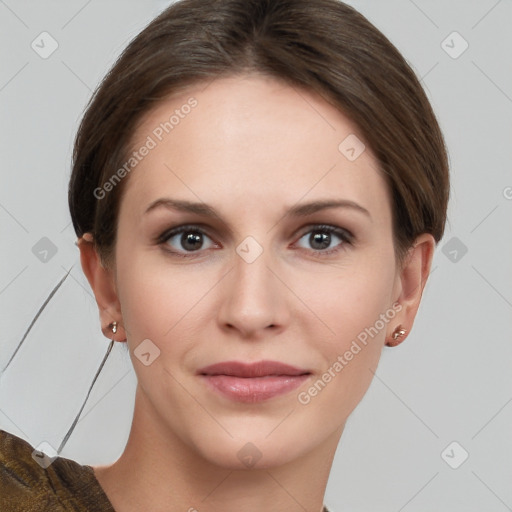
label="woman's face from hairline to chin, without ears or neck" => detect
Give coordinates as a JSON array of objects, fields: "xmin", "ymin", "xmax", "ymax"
[{"xmin": 109, "ymin": 75, "xmax": 408, "ymax": 467}]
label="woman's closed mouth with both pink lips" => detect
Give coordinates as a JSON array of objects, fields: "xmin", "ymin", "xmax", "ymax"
[{"xmin": 197, "ymin": 361, "xmax": 312, "ymax": 403}]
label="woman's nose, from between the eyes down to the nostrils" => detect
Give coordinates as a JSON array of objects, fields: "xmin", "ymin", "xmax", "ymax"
[{"xmin": 218, "ymin": 244, "xmax": 289, "ymax": 339}]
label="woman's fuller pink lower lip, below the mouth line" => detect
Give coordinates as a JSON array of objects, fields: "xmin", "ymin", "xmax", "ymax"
[{"xmin": 201, "ymin": 374, "xmax": 310, "ymax": 403}]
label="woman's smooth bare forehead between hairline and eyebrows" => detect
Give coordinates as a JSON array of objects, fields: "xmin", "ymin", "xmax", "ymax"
[{"xmin": 122, "ymin": 75, "xmax": 389, "ymax": 224}]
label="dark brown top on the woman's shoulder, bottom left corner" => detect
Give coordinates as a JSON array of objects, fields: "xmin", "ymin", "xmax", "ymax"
[{"xmin": 0, "ymin": 429, "xmax": 329, "ymax": 512}]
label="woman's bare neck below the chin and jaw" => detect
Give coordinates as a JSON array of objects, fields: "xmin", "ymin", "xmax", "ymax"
[{"xmin": 93, "ymin": 386, "xmax": 343, "ymax": 512}]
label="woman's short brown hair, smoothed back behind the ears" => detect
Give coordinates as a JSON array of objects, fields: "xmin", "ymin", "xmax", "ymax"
[{"xmin": 68, "ymin": 0, "xmax": 449, "ymax": 264}]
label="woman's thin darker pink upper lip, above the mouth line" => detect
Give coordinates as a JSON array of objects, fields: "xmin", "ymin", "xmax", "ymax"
[{"xmin": 197, "ymin": 361, "xmax": 311, "ymax": 378}]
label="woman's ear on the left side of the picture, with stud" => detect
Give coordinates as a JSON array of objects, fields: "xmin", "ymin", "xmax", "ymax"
[{"xmin": 76, "ymin": 233, "xmax": 126, "ymax": 341}]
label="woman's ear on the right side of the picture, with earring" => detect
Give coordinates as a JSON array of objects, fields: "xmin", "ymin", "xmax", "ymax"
[{"xmin": 386, "ymin": 233, "xmax": 436, "ymax": 346}]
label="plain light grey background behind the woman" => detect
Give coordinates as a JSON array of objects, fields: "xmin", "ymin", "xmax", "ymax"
[{"xmin": 0, "ymin": 0, "xmax": 512, "ymax": 512}]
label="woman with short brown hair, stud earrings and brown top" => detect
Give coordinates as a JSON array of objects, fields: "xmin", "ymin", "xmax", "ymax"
[{"xmin": 1, "ymin": 0, "xmax": 449, "ymax": 512}]
